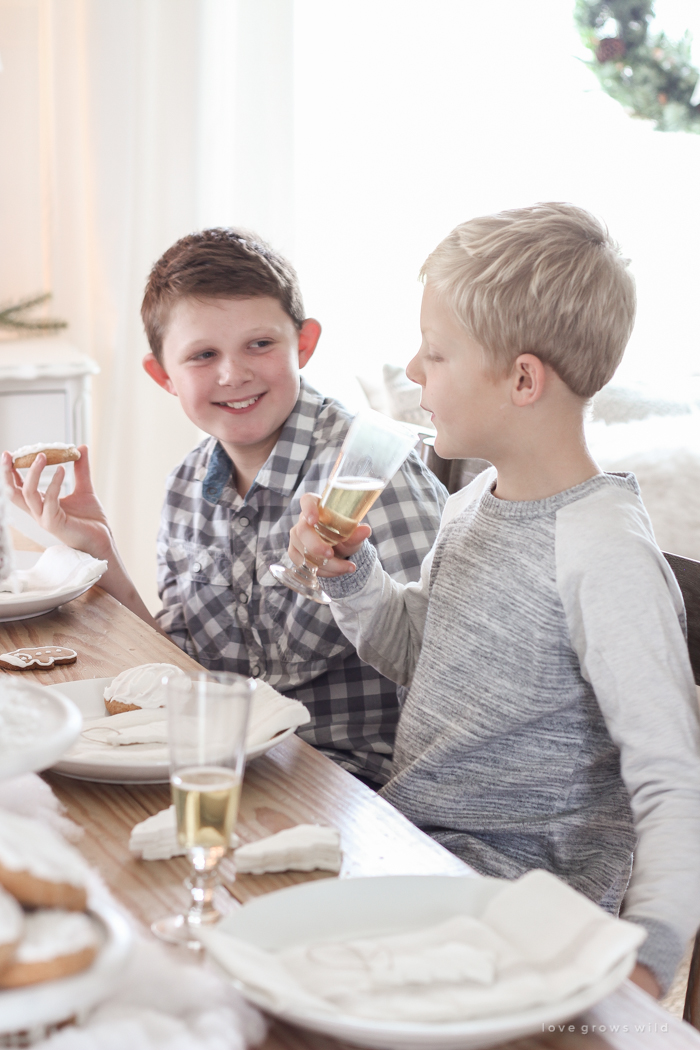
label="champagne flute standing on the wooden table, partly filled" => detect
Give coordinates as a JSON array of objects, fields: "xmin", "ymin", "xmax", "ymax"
[{"xmin": 151, "ymin": 670, "xmax": 254, "ymax": 949}]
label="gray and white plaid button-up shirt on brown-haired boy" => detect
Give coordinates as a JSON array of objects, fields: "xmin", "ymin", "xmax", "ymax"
[{"xmin": 157, "ymin": 381, "xmax": 447, "ymax": 783}]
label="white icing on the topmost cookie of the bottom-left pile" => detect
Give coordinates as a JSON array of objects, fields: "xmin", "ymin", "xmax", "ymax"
[{"xmin": 0, "ymin": 811, "xmax": 89, "ymax": 888}]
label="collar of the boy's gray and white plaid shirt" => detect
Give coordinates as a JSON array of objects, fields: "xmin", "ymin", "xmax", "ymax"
[{"xmin": 201, "ymin": 379, "xmax": 323, "ymax": 503}]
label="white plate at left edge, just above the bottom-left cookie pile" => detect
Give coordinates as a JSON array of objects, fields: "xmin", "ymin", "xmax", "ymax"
[{"xmin": 0, "ymin": 672, "xmax": 83, "ymax": 780}]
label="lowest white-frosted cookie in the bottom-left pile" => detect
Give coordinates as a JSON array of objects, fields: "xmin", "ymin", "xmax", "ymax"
[{"xmin": 0, "ymin": 908, "xmax": 99, "ymax": 988}]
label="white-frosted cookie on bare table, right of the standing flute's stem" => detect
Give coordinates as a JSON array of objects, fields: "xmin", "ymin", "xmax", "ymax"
[{"xmin": 236, "ymin": 824, "xmax": 342, "ymax": 875}]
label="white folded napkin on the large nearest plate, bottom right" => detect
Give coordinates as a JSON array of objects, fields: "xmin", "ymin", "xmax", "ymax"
[{"xmin": 203, "ymin": 870, "xmax": 645, "ymax": 1023}]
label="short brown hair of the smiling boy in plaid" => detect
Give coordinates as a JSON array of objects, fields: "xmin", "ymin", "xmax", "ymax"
[{"xmin": 141, "ymin": 228, "xmax": 304, "ymax": 364}]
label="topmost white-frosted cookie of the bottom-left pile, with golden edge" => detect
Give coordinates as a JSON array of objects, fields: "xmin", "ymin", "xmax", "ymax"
[{"xmin": 0, "ymin": 810, "xmax": 89, "ymax": 911}]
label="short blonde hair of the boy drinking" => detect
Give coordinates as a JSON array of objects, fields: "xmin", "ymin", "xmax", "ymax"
[{"xmin": 421, "ymin": 204, "xmax": 636, "ymax": 398}]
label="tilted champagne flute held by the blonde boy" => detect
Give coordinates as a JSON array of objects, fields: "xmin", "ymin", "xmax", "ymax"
[{"xmin": 270, "ymin": 412, "xmax": 418, "ymax": 605}]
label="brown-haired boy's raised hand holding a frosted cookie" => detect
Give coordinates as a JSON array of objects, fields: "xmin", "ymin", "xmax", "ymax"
[{"xmin": 2, "ymin": 445, "xmax": 112, "ymax": 559}]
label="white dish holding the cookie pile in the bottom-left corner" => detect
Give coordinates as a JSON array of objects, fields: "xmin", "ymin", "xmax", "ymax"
[{"xmin": 0, "ymin": 902, "xmax": 133, "ymax": 1045}]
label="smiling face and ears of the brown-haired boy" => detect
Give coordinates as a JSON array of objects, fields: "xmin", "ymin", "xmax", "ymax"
[{"xmin": 144, "ymin": 296, "xmax": 321, "ymax": 464}]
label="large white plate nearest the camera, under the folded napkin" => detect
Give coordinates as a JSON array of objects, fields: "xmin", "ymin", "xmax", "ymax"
[{"xmin": 218, "ymin": 876, "xmax": 635, "ymax": 1050}]
